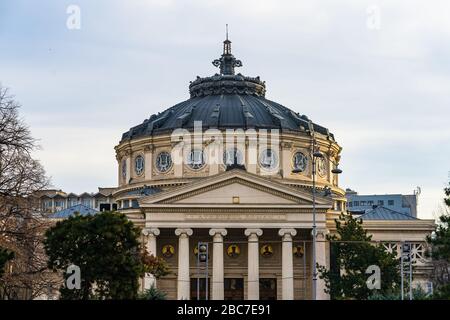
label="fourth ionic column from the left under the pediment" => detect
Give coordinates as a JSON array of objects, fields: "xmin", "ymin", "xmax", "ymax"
[{"xmin": 244, "ymin": 229, "xmax": 262, "ymax": 300}]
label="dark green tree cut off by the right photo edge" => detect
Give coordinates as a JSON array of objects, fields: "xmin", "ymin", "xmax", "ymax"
[{"xmin": 427, "ymin": 182, "xmax": 450, "ymax": 300}]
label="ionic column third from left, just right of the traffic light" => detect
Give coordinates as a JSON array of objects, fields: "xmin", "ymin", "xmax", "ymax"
[{"xmin": 209, "ymin": 229, "xmax": 227, "ymax": 300}]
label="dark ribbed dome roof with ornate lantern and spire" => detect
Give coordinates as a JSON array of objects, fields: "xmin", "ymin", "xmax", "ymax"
[{"xmin": 122, "ymin": 39, "xmax": 334, "ymax": 141}]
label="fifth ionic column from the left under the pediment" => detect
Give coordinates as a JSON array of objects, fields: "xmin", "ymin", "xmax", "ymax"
[{"xmin": 278, "ymin": 229, "xmax": 297, "ymax": 300}]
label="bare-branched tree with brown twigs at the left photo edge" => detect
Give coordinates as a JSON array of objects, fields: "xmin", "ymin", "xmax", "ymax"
[{"xmin": 0, "ymin": 85, "xmax": 55, "ymax": 299}]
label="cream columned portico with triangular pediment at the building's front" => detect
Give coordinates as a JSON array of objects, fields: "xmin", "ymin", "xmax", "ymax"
[{"xmin": 140, "ymin": 170, "xmax": 332, "ymax": 300}]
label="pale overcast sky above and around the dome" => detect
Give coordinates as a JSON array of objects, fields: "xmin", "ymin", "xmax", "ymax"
[{"xmin": 0, "ymin": 0, "xmax": 450, "ymax": 218}]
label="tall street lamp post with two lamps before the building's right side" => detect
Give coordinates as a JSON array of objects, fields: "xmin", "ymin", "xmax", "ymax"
[{"xmin": 292, "ymin": 132, "xmax": 342, "ymax": 300}]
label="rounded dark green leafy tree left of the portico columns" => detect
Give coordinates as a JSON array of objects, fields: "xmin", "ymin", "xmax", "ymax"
[{"xmin": 44, "ymin": 212, "xmax": 145, "ymax": 299}]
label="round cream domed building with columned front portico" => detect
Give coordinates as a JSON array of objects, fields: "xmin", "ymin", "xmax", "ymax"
[{"xmin": 110, "ymin": 37, "xmax": 434, "ymax": 299}]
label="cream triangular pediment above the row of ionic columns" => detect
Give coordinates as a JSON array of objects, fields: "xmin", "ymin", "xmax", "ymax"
[{"xmin": 139, "ymin": 169, "xmax": 331, "ymax": 208}]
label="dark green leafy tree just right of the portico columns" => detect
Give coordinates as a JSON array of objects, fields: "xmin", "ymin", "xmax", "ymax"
[{"xmin": 318, "ymin": 214, "xmax": 400, "ymax": 300}]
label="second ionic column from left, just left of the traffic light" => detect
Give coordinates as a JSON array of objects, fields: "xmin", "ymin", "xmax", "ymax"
[{"xmin": 175, "ymin": 228, "xmax": 193, "ymax": 300}]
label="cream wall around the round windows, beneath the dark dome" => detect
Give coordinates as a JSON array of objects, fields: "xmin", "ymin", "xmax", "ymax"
[{"xmin": 115, "ymin": 131, "xmax": 344, "ymax": 194}]
